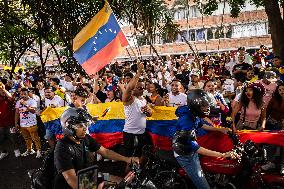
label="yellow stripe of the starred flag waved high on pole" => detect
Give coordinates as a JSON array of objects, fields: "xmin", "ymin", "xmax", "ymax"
[{"xmin": 73, "ymin": 2, "xmax": 112, "ymax": 52}]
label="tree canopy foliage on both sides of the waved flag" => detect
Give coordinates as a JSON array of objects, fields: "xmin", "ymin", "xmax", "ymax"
[{"xmin": 0, "ymin": 0, "xmax": 178, "ymax": 72}]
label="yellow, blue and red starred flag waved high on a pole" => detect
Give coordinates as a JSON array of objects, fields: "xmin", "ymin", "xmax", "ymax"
[{"xmin": 73, "ymin": 2, "xmax": 128, "ymax": 75}]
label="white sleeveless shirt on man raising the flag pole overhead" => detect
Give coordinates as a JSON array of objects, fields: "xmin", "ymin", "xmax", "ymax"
[{"xmin": 123, "ymin": 97, "xmax": 147, "ymax": 134}]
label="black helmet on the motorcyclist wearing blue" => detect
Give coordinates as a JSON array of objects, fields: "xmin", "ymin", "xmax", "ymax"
[{"xmin": 187, "ymin": 89, "xmax": 210, "ymax": 117}]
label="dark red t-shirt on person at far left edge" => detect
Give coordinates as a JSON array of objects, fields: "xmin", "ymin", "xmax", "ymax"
[{"xmin": 0, "ymin": 96, "xmax": 15, "ymax": 127}]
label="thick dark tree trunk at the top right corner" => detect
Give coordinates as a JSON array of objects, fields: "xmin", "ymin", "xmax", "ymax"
[{"xmin": 264, "ymin": 0, "xmax": 284, "ymax": 60}]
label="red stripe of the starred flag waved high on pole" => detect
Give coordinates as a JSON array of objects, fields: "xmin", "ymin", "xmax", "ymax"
[{"xmin": 82, "ymin": 31, "xmax": 128, "ymax": 75}]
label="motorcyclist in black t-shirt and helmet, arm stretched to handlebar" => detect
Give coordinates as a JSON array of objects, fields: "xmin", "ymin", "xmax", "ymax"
[{"xmin": 54, "ymin": 107, "xmax": 139, "ymax": 189}]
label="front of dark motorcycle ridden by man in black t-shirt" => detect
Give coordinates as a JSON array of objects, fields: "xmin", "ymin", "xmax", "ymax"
[{"xmin": 113, "ymin": 146, "xmax": 190, "ymax": 189}]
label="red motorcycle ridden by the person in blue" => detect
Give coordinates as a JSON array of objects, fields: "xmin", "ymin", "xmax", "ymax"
[{"xmin": 200, "ymin": 133, "xmax": 284, "ymax": 189}]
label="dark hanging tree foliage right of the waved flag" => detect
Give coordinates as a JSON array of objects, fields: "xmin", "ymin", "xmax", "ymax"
[{"xmin": 112, "ymin": 0, "xmax": 179, "ymax": 57}]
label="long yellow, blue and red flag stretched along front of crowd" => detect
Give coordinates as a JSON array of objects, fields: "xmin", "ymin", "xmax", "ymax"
[{"xmin": 41, "ymin": 102, "xmax": 284, "ymax": 152}]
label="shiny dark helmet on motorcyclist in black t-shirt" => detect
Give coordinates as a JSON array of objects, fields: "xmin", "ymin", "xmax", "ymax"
[{"xmin": 60, "ymin": 108, "xmax": 92, "ymax": 136}]
